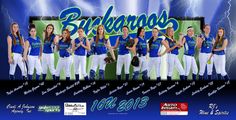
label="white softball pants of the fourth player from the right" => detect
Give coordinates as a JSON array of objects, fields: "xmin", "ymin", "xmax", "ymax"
[{"xmin": 167, "ymin": 53, "xmax": 185, "ymax": 77}]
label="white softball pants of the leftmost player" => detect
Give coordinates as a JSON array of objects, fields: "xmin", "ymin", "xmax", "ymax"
[{"xmin": 9, "ymin": 53, "xmax": 27, "ymax": 76}]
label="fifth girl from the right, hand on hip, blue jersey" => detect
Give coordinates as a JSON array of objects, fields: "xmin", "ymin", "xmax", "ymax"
[{"xmin": 148, "ymin": 28, "xmax": 169, "ymax": 80}]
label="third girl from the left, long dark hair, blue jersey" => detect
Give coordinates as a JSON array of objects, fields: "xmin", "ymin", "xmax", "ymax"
[{"xmin": 42, "ymin": 24, "xmax": 58, "ymax": 80}]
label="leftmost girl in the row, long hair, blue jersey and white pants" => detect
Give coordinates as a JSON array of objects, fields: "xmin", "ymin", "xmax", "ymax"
[{"xmin": 7, "ymin": 22, "xmax": 27, "ymax": 80}]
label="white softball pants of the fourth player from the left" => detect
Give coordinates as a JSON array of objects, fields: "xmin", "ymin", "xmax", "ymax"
[{"xmin": 55, "ymin": 57, "xmax": 71, "ymax": 77}]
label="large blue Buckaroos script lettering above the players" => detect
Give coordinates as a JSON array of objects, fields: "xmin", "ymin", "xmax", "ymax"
[{"xmin": 59, "ymin": 6, "xmax": 179, "ymax": 35}]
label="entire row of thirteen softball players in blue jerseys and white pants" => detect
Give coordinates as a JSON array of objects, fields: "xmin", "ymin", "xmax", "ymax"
[{"xmin": 7, "ymin": 23, "xmax": 229, "ymax": 80}]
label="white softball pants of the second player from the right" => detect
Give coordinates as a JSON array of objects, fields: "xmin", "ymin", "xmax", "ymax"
[{"xmin": 199, "ymin": 53, "xmax": 213, "ymax": 76}]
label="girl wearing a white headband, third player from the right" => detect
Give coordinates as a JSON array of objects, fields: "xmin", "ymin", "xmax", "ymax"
[{"xmin": 182, "ymin": 26, "xmax": 198, "ymax": 80}]
